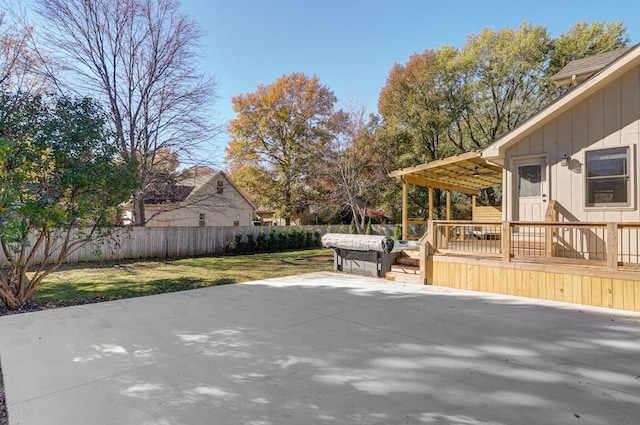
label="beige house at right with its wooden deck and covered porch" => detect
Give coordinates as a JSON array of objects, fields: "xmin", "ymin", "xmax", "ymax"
[{"xmin": 391, "ymin": 45, "xmax": 640, "ymax": 311}]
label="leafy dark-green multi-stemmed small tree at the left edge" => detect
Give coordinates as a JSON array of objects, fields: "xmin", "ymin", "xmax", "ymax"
[{"xmin": 0, "ymin": 93, "xmax": 134, "ymax": 308}]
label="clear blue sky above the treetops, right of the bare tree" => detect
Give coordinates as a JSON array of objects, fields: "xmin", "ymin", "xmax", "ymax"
[{"xmin": 182, "ymin": 0, "xmax": 640, "ymax": 167}]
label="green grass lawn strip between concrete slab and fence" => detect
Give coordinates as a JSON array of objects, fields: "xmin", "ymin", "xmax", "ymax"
[{"xmin": 34, "ymin": 249, "xmax": 333, "ymax": 304}]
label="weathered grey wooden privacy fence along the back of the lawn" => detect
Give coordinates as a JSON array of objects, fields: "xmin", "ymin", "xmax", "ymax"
[{"xmin": 0, "ymin": 224, "xmax": 408, "ymax": 264}]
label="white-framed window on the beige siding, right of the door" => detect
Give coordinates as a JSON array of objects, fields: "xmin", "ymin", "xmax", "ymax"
[{"xmin": 585, "ymin": 147, "xmax": 631, "ymax": 207}]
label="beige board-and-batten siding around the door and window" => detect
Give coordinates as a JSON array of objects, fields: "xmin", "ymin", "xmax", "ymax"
[{"xmin": 503, "ymin": 67, "xmax": 640, "ymax": 222}]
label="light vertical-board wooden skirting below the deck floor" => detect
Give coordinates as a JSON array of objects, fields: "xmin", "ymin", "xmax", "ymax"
[{"xmin": 424, "ymin": 255, "xmax": 640, "ymax": 311}]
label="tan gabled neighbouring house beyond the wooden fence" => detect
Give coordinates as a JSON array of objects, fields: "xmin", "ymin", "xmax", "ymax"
[{"xmin": 124, "ymin": 171, "xmax": 255, "ymax": 227}]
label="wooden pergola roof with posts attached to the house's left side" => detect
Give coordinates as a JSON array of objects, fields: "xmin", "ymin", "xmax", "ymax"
[{"xmin": 389, "ymin": 151, "xmax": 502, "ymax": 239}]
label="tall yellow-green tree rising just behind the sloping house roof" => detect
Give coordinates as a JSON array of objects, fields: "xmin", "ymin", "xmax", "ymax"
[{"xmin": 458, "ymin": 23, "xmax": 551, "ymax": 149}]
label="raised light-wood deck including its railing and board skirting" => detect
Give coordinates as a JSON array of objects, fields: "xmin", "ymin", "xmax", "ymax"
[{"xmin": 420, "ymin": 222, "xmax": 640, "ymax": 311}]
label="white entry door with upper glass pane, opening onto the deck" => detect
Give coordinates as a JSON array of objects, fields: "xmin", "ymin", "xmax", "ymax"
[{"xmin": 513, "ymin": 157, "xmax": 549, "ymax": 221}]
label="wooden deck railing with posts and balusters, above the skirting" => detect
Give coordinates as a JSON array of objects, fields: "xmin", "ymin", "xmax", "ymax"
[{"xmin": 424, "ymin": 221, "xmax": 640, "ymax": 270}]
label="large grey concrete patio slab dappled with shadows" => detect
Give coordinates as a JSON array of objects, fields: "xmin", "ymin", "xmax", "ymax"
[{"xmin": 0, "ymin": 273, "xmax": 640, "ymax": 425}]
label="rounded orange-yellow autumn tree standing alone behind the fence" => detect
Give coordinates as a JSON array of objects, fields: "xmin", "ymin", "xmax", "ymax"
[{"xmin": 226, "ymin": 73, "xmax": 336, "ymax": 224}]
